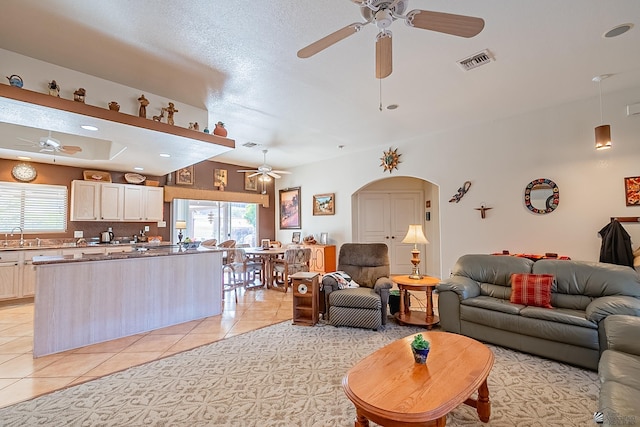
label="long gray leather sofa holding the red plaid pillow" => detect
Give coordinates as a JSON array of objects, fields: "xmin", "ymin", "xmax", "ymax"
[{"xmin": 436, "ymin": 255, "xmax": 640, "ymax": 370}]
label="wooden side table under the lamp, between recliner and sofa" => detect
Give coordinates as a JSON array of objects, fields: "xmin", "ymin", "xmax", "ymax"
[{"xmin": 391, "ymin": 275, "xmax": 440, "ymax": 329}]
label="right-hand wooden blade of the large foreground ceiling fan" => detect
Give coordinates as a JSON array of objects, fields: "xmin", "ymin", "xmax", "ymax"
[{"xmin": 407, "ymin": 9, "xmax": 484, "ymax": 38}]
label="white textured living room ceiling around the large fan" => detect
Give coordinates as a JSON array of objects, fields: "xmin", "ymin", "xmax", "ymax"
[{"xmin": 0, "ymin": 0, "xmax": 640, "ymax": 174}]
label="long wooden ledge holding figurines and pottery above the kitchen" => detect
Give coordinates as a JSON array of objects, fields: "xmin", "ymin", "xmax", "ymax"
[{"xmin": 0, "ymin": 84, "xmax": 235, "ymax": 148}]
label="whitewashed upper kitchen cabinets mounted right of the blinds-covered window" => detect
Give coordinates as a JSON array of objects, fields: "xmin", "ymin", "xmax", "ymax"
[{"xmin": 71, "ymin": 180, "xmax": 164, "ymax": 222}]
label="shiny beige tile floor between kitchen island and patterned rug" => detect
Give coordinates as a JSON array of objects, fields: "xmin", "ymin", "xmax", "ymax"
[{"xmin": 0, "ymin": 288, "xmax": 292, "ymax": 407}]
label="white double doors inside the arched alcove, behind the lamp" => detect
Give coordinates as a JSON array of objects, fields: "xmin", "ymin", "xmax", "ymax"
[{"xmin": 358, "ymin": 192, "xmax": 424, "ymax": 274}]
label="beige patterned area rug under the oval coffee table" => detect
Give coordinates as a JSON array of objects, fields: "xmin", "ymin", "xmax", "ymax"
[{"xmin": 0, "ymin": 321, "xmax": 599, "ymax": 427}]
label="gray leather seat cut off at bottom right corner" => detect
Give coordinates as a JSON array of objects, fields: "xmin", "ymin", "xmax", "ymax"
[{"xmin": 598, "ymin": 315, "xmax": 640, "ymax": 426}]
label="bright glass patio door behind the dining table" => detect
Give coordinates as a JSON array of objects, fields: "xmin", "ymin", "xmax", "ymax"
[{"xmin": 174, "ymin": 199, "xmax": 258, "ymax": 246}]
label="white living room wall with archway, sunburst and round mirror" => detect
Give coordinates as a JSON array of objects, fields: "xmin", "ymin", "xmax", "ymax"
[{"xmin": 276, "ymin": 88, "xmax": 640, "ymax": 276}]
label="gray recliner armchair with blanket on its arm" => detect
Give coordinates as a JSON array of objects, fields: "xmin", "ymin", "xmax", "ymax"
[{"xmin": 322, "ymin": 243, "xmax": 393, "ymax": 330}]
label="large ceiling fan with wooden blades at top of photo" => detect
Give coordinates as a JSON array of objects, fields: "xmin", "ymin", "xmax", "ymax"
[{"xmin": 298, "ymin": 0, "xmax": 484, "ymax": 79}]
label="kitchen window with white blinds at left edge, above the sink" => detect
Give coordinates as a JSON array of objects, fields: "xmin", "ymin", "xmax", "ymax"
[{"xmin": 0, "ymin": 182, "xmax": 67, "ymax": 233}]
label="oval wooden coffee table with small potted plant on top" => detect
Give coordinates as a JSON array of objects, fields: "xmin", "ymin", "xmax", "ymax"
[{"xmin": 342, "ymin": 332, "xmax": 493, "ymax": 427}]
